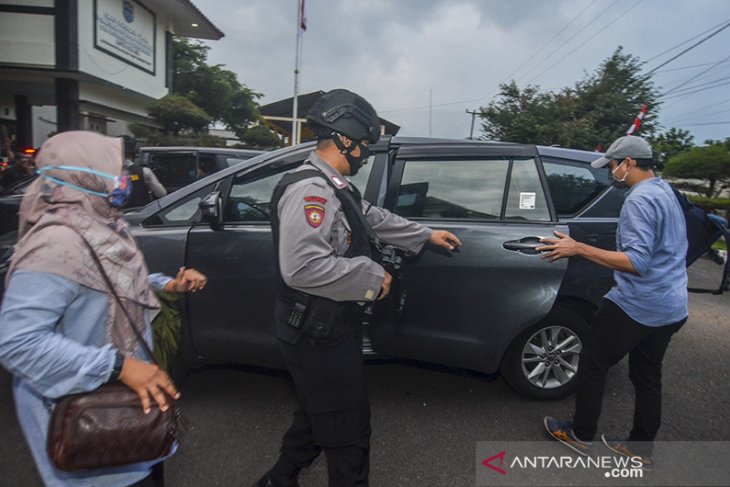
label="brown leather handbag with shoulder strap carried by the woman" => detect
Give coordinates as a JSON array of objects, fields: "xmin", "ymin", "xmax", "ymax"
[{"xmin": 48, "ymin": 237, "xmax": 184, "ymax": 472}]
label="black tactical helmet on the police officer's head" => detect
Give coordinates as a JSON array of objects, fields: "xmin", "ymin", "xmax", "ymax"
[{"xmin": 307, "ymin": 89, "xmax": 380, "ymax": 144}]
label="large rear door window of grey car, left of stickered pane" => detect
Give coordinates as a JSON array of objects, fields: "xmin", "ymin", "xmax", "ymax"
[{"xmin": 395, "ymin": 160, "xmax": 509, "ymax": 220}]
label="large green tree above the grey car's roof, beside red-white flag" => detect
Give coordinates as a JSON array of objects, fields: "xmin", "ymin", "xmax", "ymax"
[{"xmin": 481, "ymin": 47, "xmax": 659, "ymax": 150}]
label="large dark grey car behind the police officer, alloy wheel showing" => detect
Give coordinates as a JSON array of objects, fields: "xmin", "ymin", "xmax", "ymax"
[{"xmin": 116, "ymin": 137, "xmax": 623, "ymax": 398}]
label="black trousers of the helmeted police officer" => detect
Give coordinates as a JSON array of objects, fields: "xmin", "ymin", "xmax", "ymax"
[{"xmin": 269, "ymin": 300, "xmax": 371, "ymax": 487}]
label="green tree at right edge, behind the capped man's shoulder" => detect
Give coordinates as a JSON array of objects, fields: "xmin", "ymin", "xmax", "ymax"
[{"xmin": 664, "ymin": 141, "xmax": 730, "ymax": 198}]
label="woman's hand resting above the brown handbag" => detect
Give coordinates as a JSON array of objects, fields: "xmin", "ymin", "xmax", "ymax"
[{"xmin": 119, "ymin": 358, "xmax": 180, "ymax": 414}]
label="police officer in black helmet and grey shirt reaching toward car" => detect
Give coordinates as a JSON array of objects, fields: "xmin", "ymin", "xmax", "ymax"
[{"xmin": 255, "ymin": 90, "xmax": 461, "ymax": 486}]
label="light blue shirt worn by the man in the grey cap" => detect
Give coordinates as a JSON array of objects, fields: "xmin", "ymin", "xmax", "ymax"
[{"xmin": 605, "ymin": 178, "xmax": 688, "ymax": 326}]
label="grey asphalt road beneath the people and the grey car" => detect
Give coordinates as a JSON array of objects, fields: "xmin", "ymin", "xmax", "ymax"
[{"xmin": 0, "ymin": 259, "xmax": 730, "ymax": 487}]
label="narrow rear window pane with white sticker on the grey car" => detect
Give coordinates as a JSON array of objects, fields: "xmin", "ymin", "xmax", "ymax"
[{"xmin": 504, "ymin": 159, "xmax": 550, "ymax": 221}]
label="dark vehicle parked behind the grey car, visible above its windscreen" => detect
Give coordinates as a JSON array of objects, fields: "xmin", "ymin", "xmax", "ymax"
[{"xmin": 137, "ymin": 146, "xmax": 262, "ymax": 193}]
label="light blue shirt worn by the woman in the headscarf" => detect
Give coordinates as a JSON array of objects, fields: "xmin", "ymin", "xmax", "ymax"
[{"xmin": 0, "ymin": 270, "xmax": 170, "ymax": 487}]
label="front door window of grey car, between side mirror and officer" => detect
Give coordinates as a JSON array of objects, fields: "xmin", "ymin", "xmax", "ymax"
[{"xmin": 223, "ymin": 166, "xmax": 294, "ymax": 223}]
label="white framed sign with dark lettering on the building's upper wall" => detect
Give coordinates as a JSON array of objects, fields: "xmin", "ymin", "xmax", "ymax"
[{"xmin": 94, "ymin": 0, "xmax": 157, "ymax": 75}]
